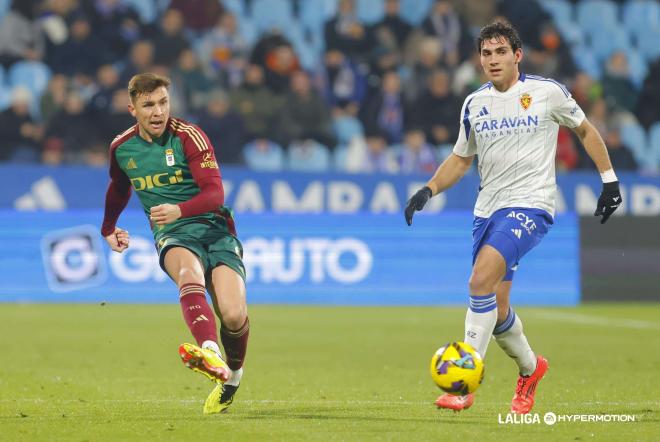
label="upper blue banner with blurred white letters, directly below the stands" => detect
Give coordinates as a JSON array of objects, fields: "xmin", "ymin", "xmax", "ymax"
[{"xmin": 0, "ymin": 165, "xmax": 660, "ymax": 216}]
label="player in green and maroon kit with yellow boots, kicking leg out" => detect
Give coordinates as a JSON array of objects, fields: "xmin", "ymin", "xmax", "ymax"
[{"xmin": 101, "ymin": 73, "xmax": 250, "ymax": 414}]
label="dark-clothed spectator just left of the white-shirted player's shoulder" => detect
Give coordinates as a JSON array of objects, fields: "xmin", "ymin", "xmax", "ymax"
[{"xmin": 411, "ymin": 69, "xmax": 461, "ymax": 146}]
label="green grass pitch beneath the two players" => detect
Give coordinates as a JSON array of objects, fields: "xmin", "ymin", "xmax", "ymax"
[{"xmin": 0, "ymin": 304, "xmax": 660, "ymax": 442}]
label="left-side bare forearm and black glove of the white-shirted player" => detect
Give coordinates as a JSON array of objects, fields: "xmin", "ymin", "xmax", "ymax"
[{"xmin": 404, "ymin": 153, "xmax": 474, "ymax": 226}]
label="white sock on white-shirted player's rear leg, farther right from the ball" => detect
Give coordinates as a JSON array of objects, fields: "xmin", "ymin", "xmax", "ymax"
[{"xmin": 493, "ymin": 307, "xmax": 536, "ymax": 376}]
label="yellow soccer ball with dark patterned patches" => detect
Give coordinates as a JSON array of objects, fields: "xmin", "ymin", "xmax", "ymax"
[{"xmin": 431, "ymin": 342, "xmax": 484, "ymax": 396}]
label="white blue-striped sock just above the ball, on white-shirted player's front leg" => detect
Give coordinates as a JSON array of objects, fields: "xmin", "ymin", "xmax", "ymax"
[{"xmin": 465, "ymin": 293, "xmax": 497, "ymax": 358}]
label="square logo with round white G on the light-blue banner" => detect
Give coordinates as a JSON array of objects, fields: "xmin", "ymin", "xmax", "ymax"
[{"xmin": 41, "ymin": 226, "xmax": 107, "ymax": 292}]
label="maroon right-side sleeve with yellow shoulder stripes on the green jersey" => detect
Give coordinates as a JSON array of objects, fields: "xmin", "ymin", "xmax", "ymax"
[{"xmin": 179, "ymin": 122, "xmax": 225, "ymax": 218}]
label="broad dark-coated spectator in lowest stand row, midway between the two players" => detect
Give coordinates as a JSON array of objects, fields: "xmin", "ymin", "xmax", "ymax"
[{"xmin": 279, "ymin": 71, "xmax": 336, "ymax": 147}]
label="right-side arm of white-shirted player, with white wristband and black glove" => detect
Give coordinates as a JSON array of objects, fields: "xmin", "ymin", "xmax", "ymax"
[{"xmin": 573, "ymin": 118, "xmax": 623, "ymax": 224}]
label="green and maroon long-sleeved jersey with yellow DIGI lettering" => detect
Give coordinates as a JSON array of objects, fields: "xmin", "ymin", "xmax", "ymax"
[{"xmin": 101, "ymin": 118, "xmax": 236, "ymax": 238}]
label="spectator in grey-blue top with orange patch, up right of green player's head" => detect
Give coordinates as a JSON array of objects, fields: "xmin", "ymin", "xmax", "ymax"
[{"xmin": 197, "ymin": 12, "xmax": 250, "ymax": 87}]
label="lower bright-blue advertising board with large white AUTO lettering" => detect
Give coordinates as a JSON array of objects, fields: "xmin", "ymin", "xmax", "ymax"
[{"xmin": 0, "ymin": 210, "xmax": 580, "ymax": 305}]
